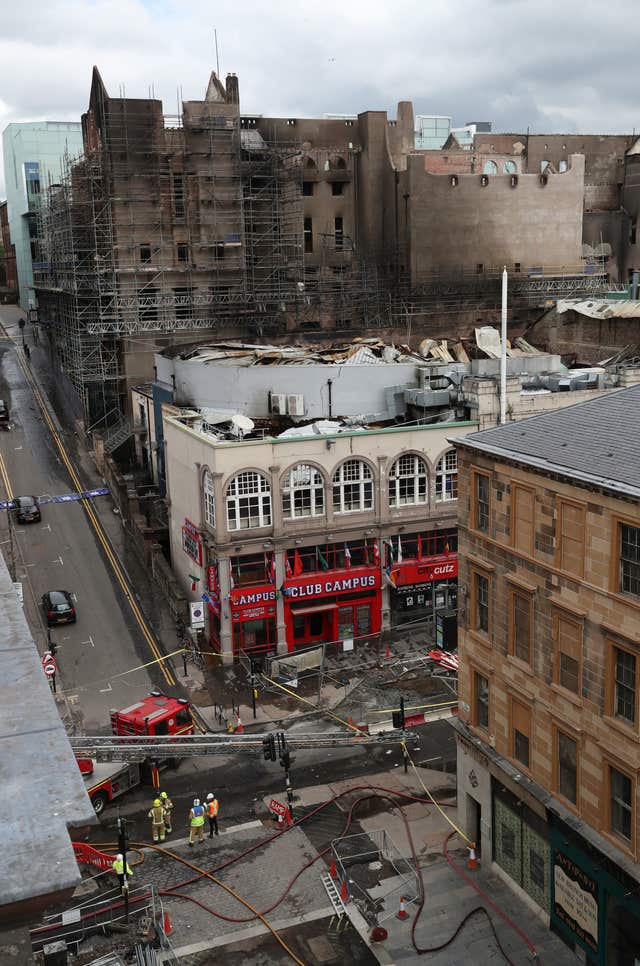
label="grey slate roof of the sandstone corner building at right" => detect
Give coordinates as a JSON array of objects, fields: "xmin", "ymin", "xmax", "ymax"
[{"xmin": 455, "ymin": 385, "xmax": 640, "ymax": 497}]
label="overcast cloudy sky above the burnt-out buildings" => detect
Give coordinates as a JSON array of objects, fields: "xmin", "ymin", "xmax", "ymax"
[{"xmin": 0, "ymin": 0, "xmax": 640, "ymax": 197}]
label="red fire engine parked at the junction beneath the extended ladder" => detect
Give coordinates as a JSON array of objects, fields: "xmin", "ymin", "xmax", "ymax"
[{"xmin": 78, "ymin": 691, "xmax": 193, "ymax": 815}]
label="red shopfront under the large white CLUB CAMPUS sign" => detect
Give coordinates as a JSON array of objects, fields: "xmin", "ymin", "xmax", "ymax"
[{"xmin": 283, "ymin": 566, "xmax": 382, "ymax": 651}]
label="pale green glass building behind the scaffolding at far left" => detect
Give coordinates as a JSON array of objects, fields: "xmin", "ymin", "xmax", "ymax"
[{"xmin": 2, "ymin": 121, "xmax": 82, "ymax": 312}]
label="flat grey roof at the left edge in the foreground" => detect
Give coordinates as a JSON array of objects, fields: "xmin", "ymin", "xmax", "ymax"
[{"xmin": 0, "ymin": 555, "xmax": 97, "ymax": 918}]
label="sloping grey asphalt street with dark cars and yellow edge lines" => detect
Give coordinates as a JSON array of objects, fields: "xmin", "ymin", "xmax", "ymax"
[{"xmin": 0, "ymin": 309, "xmax": 166, "ymax": 733}]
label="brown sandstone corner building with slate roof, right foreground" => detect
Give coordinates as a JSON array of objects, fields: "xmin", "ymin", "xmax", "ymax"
[{"xmin": 455, "ymin": 386, "xmax": 640, "ymax": 964}]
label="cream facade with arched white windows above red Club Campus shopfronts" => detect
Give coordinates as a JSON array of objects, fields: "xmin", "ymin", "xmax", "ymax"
[{"xmin": 163, "ymin": 412, "xmax": 475, "ymax": 661}]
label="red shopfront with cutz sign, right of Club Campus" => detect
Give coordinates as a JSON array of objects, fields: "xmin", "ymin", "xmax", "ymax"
[{"xmin": 390, "ymin": 554, "xmax": 458, "ymax": 627}]
